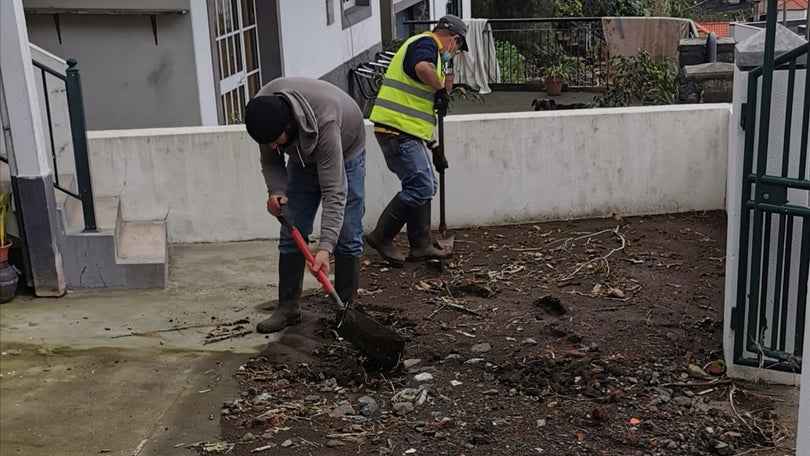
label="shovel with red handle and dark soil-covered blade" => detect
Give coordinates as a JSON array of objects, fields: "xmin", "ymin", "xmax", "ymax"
[{"xmin": 277, "ymin": 215, "xmax": 405, "ymax": 369}]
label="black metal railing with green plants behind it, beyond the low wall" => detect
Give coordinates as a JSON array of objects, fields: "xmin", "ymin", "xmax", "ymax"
[{"xmin": 405, "ymin": 17, "xmax": 607, "ymax": 90}]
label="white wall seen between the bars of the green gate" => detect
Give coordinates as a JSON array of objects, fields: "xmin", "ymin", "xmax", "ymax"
[{"xmin": 723, "ymin": 68, "xmax": 810, "ymax": 384}]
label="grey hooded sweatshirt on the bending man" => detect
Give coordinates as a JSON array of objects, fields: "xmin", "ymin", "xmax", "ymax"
[{"xmin": 256, "ymin": 78, "xmax": 366, "ymax": 254}]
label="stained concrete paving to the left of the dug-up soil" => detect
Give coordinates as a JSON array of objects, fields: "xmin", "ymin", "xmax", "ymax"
[{"xmin": 0, "ymin": 242, "xmax": 318, "ymax": 456}]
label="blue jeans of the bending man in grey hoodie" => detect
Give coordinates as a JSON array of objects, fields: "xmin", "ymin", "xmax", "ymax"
[{"xmin": 278, "ymin": 150, "xmax": 366, "ymax": 256}]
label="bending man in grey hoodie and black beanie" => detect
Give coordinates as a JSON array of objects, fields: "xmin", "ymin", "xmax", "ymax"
[{"xmin": 245, "ymin": 77, "xmax": 366, "ymax": 333}]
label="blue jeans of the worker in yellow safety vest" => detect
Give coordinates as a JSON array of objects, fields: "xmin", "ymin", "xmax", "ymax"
[{"xmin": 374, "ymin": 133, "xmax": 439, "ymax": 207}]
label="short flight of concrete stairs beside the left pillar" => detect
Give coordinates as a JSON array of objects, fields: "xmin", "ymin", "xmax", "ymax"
[{"xmin": 56, "ymin": 175, "xmax": 168, "ymax": 289}]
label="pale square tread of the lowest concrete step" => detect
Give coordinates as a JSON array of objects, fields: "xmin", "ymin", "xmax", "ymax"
[{"xmin": 115, "ymin": 220, "xmax": 166, "ymax": 264}]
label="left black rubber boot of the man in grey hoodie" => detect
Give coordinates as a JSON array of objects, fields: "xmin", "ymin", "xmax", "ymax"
[{"xmin": 256, "ymin": 253, "xmax": 306, "ymax": 334}]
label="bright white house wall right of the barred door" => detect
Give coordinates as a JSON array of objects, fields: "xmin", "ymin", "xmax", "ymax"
[{"xmin": 279, "ymin": 0, "xmax": 382, "ymax": 78}]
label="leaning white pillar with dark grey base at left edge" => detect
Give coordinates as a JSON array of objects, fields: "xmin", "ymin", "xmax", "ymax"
[{"xmin": 0, "ymin": 0, "xmax": 65, "ymax": 296}]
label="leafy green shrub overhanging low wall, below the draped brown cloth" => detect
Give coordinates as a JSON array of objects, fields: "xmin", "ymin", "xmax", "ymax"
[{"xmin": 594, "ymin": 50, "xmax": 678, "ymax": 107}]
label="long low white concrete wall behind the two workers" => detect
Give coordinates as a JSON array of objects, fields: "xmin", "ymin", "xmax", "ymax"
[{"xmin": 89, "ymin": 104, "xmax": 729, "ymax": 243}]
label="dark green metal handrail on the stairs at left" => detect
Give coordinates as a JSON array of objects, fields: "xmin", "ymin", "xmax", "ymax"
[{"xmin": 33, "ymin": 59, "xmax": 97, "ymax": 231}]
